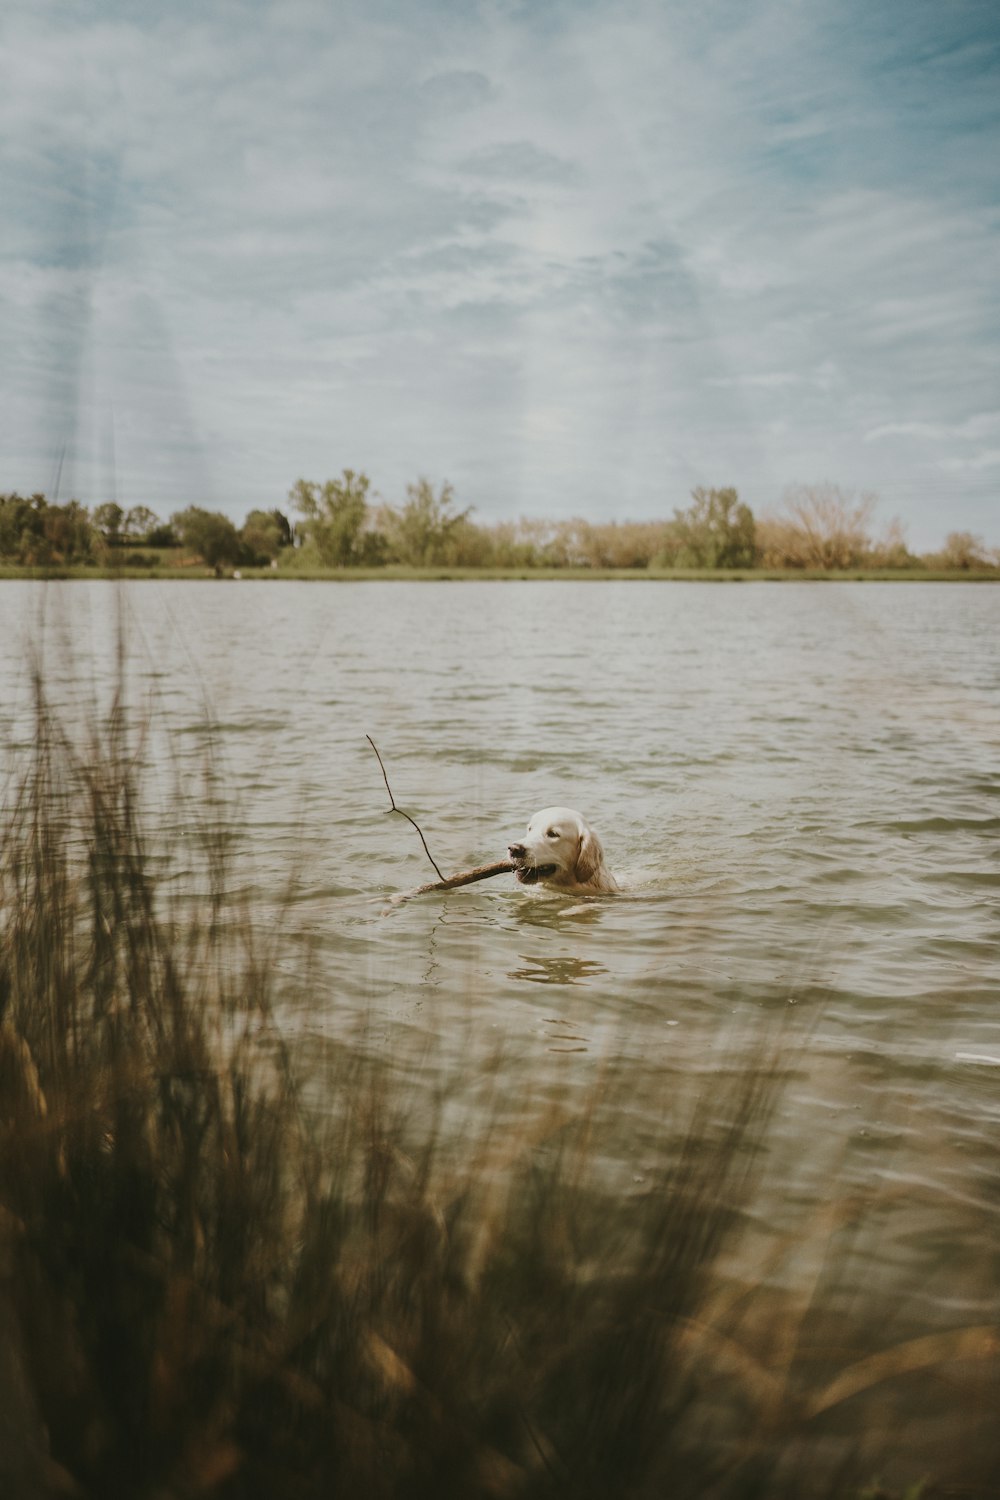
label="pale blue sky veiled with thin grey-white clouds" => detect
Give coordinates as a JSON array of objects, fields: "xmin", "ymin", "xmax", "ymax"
[{"xmin": 0, "ymin": 0, "xmax": 1000, "ymax": 551}]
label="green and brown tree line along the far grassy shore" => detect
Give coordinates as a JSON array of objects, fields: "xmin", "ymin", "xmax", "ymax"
[{"xmin": 0, "ymin": 470, "xmax": 1000, "ymax": 573}]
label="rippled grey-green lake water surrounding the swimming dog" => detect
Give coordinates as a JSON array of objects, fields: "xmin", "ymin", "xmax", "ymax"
[{"xmin": 0, "ymin": 581, "xmax": 1000, "ymax": 1482}]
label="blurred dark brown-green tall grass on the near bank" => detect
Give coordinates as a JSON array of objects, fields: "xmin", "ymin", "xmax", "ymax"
[{"xmin": 0, "ymin": 642, "xmax": 1000, "ymax": 1500}]
